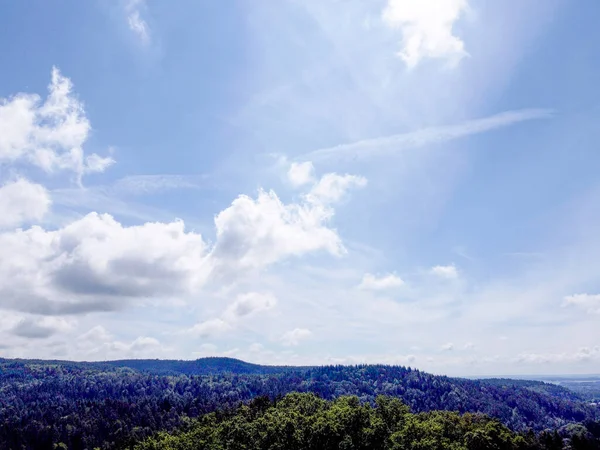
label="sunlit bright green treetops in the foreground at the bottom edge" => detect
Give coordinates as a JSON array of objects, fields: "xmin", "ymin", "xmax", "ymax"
[{"xmin": 135, "ymin": 393, "xmax": 543, "ymax": 450}]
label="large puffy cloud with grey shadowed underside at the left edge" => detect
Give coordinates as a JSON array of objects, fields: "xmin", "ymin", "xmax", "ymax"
[{"xmin": 0, "ymin": 213, "xmax": 210, "ymax": 314}]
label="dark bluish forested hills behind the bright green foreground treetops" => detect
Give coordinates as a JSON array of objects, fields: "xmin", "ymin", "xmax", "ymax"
[{"xmin": 0, "ymin": 358, "xmax": 600, "ymax": 449}]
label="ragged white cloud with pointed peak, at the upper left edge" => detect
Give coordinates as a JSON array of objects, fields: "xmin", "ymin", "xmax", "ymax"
[{"xmin": 0, "ymin": 67, "xmax": 114, "ymax": 181}]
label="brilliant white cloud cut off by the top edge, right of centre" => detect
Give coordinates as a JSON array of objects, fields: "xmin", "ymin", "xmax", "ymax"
[{"xmin": 382, "ymin": 0, "xmax": 469, "ymax": 68}]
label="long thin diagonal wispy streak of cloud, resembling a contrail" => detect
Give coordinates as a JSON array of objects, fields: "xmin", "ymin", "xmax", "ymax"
[{"xmin": 301, "ymin": 109, "xmax": 554, "ymax": 161}]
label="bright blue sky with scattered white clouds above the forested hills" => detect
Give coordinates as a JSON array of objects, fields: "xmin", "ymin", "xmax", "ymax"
[{"xmin": 0, "ymin": 0, "xmax": 600, "ymax": 376}]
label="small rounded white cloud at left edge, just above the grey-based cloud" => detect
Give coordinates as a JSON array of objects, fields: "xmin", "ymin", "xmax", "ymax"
[{"xmin": 0, "ymin": 178, "xmax": 52, "ymax": 228}]
